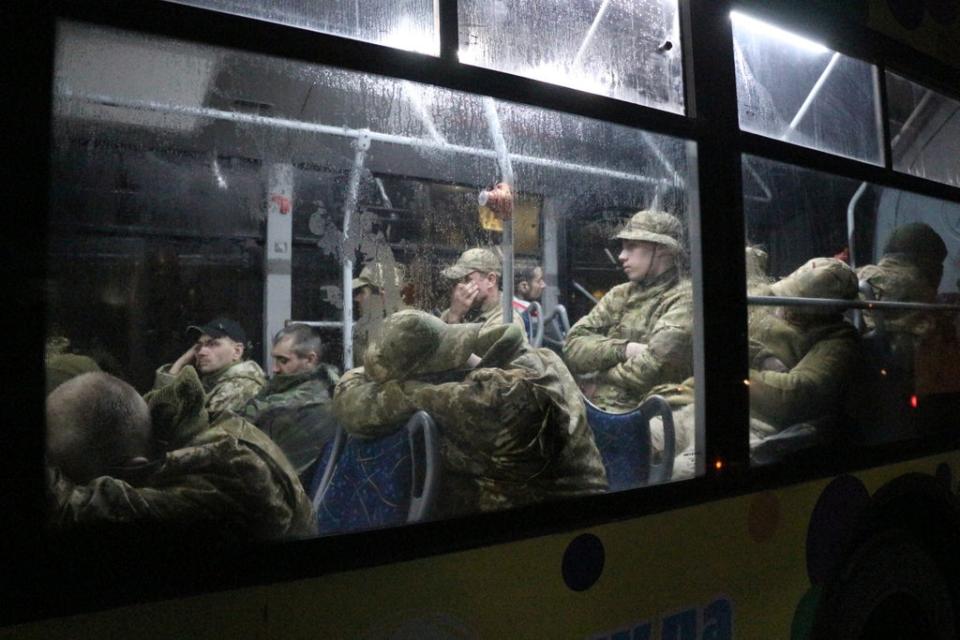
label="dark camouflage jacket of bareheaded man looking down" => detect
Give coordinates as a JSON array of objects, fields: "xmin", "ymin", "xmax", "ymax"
[{"xmin": 237, "ymin": 364, "xmax": 340, "ymax": 474}]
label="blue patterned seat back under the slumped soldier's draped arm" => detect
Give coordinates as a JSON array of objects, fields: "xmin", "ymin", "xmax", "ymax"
[{"xmin": 314, "ymin": 411, "xmax": 440, "ymax": 534}]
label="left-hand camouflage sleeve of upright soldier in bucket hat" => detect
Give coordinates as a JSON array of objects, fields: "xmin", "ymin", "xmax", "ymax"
[{"xmin": 563, "ymin": 289, "xmax": 627, "ymax": 374}]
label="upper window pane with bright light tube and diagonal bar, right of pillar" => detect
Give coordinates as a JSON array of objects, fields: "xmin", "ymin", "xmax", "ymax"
[{"xmin": 731, "ymin": 12, "xmax": 883, "ymax": 164}]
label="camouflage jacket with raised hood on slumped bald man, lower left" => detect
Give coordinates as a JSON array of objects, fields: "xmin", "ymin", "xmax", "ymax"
[{"xmin": 50, "ymin": 367, "xmax": 316, "ymax": 541}]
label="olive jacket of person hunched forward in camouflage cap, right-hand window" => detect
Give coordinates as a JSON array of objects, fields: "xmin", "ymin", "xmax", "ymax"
[{"xmin": 750, "ymin": 316, "xmax": 860, "ymax": 430}]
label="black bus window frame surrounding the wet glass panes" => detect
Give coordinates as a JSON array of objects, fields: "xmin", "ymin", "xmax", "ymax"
[{"xmin": 7, "ymin": 0, "xmax": 960, "ymax": 624}]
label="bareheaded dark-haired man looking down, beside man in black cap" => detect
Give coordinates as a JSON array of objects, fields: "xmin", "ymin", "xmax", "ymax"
[{"xmin": 237, "ymin": 324, "xmax": 340, "ymax": 480}]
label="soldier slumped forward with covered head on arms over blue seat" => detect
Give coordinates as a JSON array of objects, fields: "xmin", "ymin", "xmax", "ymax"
[{"xmin": 334, "ymin": 311, "xmax": 607, "ymax": 517}]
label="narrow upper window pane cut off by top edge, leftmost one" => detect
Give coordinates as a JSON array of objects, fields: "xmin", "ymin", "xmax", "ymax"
[{"xmin": 170, "ymin": 0, "xmax": 440, "ymax": 56}]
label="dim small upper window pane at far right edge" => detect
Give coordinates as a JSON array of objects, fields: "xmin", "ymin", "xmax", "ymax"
[{"xmin": 887, "ymin": 71, "xmax": 960, "ymax": 186}]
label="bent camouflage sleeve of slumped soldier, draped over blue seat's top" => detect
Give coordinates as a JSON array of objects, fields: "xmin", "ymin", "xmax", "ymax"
[{"xmin": 333, "ymin": 367, "xmax": 417, "ymax": 438}]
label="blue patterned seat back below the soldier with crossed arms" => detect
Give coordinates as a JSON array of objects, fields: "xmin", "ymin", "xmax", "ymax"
[{"xmin": 584, "ymin": 396, "xmax": 676, "ymax": 491}]
